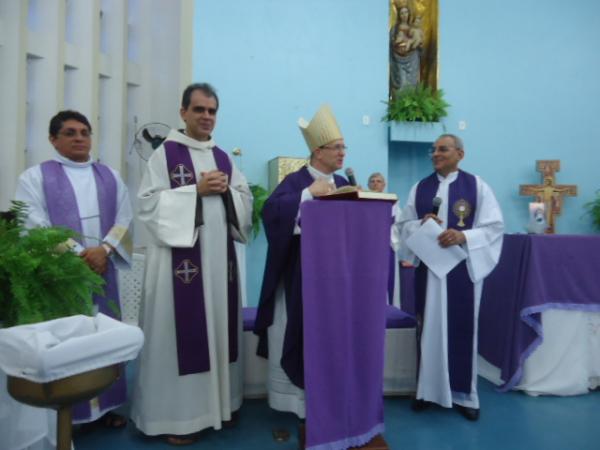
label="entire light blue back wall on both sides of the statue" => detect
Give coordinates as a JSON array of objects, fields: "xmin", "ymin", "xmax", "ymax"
[{"xmin": 194, "ymin": 0, "xmax": 600, "ymax": 304}]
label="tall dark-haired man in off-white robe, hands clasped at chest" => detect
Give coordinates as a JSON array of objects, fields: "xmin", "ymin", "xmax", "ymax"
[{"xmin": 132, "ymin": 83, "xmax": 252, "ymax": 445}]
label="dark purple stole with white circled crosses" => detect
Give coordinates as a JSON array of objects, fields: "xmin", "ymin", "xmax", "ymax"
[{"xmin": 163, "ymin": 141, "xmax": 239, "ymax": 375}]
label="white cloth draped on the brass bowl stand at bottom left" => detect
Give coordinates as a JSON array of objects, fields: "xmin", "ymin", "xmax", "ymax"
[{"xmin": 0, "ymin": 314, "xmax": 144, "ymax": 450}]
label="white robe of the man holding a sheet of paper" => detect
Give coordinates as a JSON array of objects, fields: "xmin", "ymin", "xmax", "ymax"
[{"xmin": 396, "ymin": 172, "xmax": 504, "ymax": 408}]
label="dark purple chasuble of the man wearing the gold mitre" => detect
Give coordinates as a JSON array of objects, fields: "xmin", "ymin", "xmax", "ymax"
[{"xmin": 254, "ymin": 167, "xmax": 348, "ymax": 389}]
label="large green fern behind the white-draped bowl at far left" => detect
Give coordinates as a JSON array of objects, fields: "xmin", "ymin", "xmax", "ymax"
[{"xmin": 0, "ymin": 202, "xmax": 104, "ymax": 326}]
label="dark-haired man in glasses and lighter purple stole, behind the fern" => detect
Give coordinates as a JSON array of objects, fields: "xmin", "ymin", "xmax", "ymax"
[{"xmin": 15, "ymin": 111, "xmax": 132, "ymax": 428}]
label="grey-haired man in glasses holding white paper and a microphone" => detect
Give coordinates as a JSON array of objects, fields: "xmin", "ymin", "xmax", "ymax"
[{"xmin": 397, "ymin": 134, "xmax": 504, "ymax": 420}]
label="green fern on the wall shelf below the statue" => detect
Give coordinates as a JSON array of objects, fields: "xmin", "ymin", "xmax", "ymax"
[{"xmin": 383, "ymin": 84, "xmax": 450, "ymax": 122}]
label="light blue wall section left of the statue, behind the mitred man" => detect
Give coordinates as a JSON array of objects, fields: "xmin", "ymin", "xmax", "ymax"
[{"xmin": 194, "ymin": 0, "xmax": 388, "ymax": 304}]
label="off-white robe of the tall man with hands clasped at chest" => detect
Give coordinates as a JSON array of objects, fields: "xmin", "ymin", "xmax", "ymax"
[{"xmin": 131, "ymin": 130, "xmax": 252, "ymax": 435}]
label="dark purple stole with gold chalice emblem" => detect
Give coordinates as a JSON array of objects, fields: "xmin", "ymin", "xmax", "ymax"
[{"xmin": 415, "ymin": 170, "xmax": 477, "ymax": 393}]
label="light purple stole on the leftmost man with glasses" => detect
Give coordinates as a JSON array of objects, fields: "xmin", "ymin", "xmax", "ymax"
[{"xmin": 41, "ymin": 160, "xmax": 127, "ymax": 420}]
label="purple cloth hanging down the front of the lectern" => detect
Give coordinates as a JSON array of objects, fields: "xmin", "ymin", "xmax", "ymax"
[{"xmin": 301, "ymin": 201, "xmax": 391, "ymax": 450}]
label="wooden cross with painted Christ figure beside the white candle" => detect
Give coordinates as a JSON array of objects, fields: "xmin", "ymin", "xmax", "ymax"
[{"xmin": 519, "ymin": 160, "xmax": 577, "ymax": 234}]
